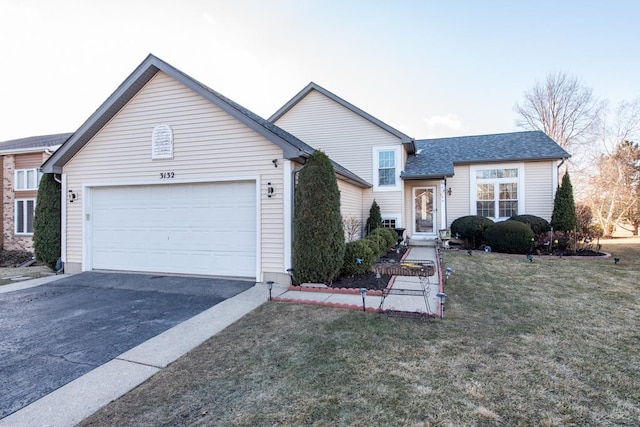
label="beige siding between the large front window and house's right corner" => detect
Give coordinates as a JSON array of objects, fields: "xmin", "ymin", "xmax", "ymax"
[{"xmin": 521, "ymin": 162, "xmax": 557, "ymax": 221}]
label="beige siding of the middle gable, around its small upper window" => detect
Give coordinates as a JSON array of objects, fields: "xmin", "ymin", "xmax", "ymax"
[{"xmin": 275, "ymin": 90, "xmax": 406, "ymax": 231}]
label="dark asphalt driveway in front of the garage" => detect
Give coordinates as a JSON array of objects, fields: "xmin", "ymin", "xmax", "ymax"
[{"xmin": 0, "ymin": 272, "xmax": 254, "ymax": 418}]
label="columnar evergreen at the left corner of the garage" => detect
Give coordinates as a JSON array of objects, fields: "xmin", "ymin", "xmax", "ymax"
[{"xmin": 33, "ymin": 173, "xmax": 61, "ymax": 269}]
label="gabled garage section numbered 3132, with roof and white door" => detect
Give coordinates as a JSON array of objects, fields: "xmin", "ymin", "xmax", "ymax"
[{"xmin": 41, "ymin": 55, "xmax": 370, "ymax": 281}]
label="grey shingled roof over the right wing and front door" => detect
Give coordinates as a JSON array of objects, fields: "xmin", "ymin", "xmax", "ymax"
[{"xmin": 401, "ymin": 131, "xmax": 570, "ymax": 179}]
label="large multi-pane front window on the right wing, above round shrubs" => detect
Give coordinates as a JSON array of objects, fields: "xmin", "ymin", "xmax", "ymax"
[{"xmin": 472, "ymin": 167, "xmax": 521, "ymax": 220}]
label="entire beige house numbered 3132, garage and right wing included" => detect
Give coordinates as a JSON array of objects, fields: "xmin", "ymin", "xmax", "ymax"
[{"xmin": 23, "ymin": 55, "xmax": 569, "ymax": 288}]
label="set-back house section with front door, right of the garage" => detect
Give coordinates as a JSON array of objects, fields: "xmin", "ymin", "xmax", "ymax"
[{"xmin": 269, "ymin": 83, "xmax": 569, "ymax": 241}]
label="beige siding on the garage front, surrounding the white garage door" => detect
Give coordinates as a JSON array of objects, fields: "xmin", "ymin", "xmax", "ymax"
[{"xmin": 64, "ymin": 72, "xmax": 284, "ymax": 280}]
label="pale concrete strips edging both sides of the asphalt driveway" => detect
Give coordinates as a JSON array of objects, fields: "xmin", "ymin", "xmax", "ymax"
[{"xmin": 0, "ymin": 275, "xmax": 285, "ymax": 427}]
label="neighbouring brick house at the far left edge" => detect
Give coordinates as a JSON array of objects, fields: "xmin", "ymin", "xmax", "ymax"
[{"xmin": 0, "ymin": 133, "xmax": 71, "ymax": 252}]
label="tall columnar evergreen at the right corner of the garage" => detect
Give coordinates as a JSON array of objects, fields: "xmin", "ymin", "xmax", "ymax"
[{"xmin": 293, "ymin": 150, "xmax": 345, "ymax": 284}]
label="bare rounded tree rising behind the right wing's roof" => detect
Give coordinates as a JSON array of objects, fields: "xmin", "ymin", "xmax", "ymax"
[{"xmin": 514, "ymin": 72, "xmax": 604, "ymax": 151}]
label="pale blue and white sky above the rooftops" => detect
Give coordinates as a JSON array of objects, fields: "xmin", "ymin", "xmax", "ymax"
[{"xmin": 0, "ymin": 0, "xmax": 640, "ymax": 140}]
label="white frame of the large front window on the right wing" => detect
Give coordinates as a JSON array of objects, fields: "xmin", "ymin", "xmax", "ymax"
[{"xmin": 469, "ymin": 163, "xmax": 526, "ymax": 221}]
